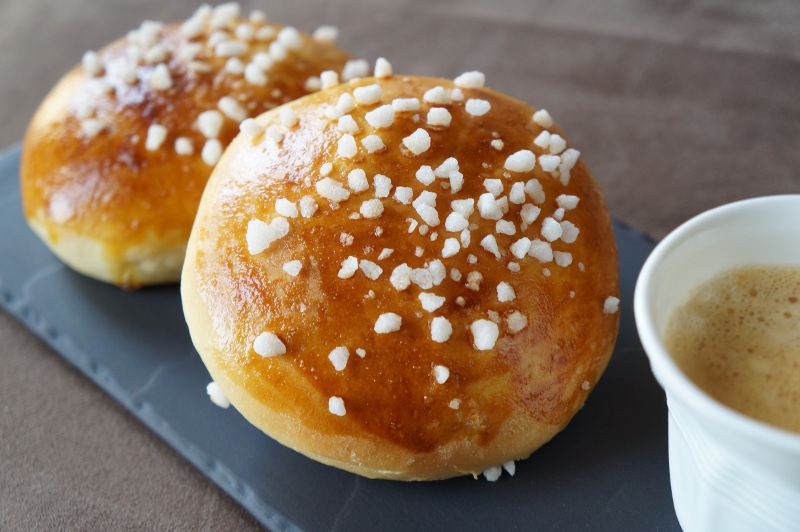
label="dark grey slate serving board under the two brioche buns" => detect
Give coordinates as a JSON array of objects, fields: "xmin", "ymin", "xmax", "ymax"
[{"xmin": 0, "ymin": 147, "xmax": 680, "ymax": 531}]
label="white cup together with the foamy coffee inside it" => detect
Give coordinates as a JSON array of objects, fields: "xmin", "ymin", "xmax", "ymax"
[{"xmin": 634, "ymin": 195, "xmax": 800, "ymax": 532}]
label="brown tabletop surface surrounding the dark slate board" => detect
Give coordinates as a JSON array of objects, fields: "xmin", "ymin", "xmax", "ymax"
[{"xmin": 0, "ymin": 0, "xmax": 800, "ymax": 530}]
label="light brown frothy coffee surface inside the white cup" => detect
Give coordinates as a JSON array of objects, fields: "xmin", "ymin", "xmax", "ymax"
[{"xmin": 664, "ymin": 265, "xmax": 800, "ymax": 433}]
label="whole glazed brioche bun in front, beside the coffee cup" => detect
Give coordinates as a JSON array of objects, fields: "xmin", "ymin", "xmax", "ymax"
[{"xmin": 181, "ymin": 61, "xmax": 618, "ymax": 480}]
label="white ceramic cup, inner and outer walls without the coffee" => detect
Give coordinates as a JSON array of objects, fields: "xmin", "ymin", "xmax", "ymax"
[{"xmin": 634, "ymin": 195, "xmax": 800, "ymax": 532}]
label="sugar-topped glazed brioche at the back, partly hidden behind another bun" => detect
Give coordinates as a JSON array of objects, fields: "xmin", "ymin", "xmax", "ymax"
[{"xmin": 21, "ymin": 3, "xmax": 352, "ymax": 287}]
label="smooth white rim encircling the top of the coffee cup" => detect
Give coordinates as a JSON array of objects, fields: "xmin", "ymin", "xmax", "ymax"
[{"xmin": 633, "ymin": 194, "xmax": 800, "ymax": 452}]
